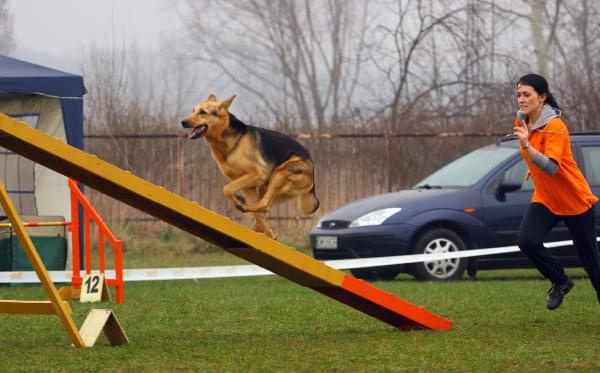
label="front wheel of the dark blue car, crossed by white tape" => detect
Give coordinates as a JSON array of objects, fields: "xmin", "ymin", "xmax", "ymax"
[{"xmin": 412, "ymin": 228, "xmax": 467, "ymax": 281}]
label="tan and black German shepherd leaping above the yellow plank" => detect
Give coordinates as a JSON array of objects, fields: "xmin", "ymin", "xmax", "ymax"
[{"xmin": 181, "ymin": 95, "xmax": 319, "ymax": 239}]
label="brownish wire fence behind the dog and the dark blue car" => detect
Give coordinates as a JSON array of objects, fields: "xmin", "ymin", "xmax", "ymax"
[{"xmin": 85, "ymin": 132, "xmax": 504, "ymax": 240}]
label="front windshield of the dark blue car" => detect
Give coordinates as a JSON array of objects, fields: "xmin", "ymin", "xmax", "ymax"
[{"xmin": 414, "ymin": 146, "xmax": 518, "ymax": 189}]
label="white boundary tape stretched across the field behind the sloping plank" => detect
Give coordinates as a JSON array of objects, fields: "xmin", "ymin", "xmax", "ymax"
[{"xmin": 0, "ymin": 237, "xmax": 600, "ymax": 284}]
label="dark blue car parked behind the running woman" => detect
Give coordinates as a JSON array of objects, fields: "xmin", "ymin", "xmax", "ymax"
[{"xmin": 310, "ymin": 133, "xmax": 600, "ymax": 280}]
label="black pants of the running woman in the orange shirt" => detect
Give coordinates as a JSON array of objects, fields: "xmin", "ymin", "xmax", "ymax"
[{"xmin": 517, "ymin": 203, "xmax": 600, "ymax": 292}]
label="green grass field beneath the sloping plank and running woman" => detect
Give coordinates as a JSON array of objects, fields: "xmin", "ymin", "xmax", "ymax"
[{"xmin": 0, "ymin": 254, "xmax": 600, "ymax": 372}]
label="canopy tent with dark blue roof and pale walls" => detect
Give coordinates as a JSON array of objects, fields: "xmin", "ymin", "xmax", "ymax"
[{"xmin": 0, "ymin": 55, "xmax": 86, "ymax": 270}]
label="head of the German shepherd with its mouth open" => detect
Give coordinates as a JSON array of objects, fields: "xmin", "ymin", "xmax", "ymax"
[{"xmin": 181, "ymin": 95, "xmax": 235, "ymax": 139}]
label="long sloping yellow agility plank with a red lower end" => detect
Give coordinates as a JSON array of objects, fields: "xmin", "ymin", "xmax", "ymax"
[{"xmin": 0, "ymin": 113, "xmax": 452, "ymax": 330}]
